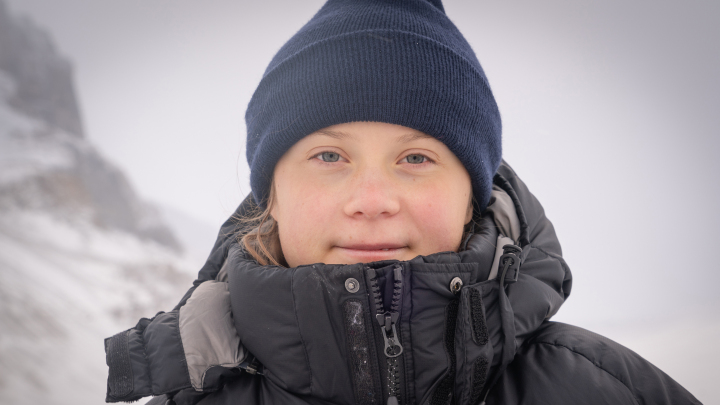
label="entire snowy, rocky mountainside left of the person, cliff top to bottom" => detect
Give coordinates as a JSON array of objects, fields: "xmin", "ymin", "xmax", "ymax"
[{"xmin": 0, "ymin": 0, "xmax": 197, "ymax": 405}]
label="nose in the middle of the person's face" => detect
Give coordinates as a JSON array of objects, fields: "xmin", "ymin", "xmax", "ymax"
[{"xmin": 344, "ymin": 166, "xmax": 400, "ymax": 219}]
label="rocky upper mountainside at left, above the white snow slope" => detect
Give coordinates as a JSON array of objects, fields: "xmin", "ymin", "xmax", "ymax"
[{"xmin": 0, "ymin": 1, "xmax": 180, "ymax": 251}]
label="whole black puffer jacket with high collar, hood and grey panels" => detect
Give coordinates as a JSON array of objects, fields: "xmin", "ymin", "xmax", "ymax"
[{"xmin": 106, "ymin": 163, "xmax": 699, "ymax": 405}]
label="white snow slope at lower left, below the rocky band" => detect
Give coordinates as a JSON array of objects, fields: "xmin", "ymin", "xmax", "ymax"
[{"xmin": 0, "ymin": 210, "xmax": 196, "ymax": 404}]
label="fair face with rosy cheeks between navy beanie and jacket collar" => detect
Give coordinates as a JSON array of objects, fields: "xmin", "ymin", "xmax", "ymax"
[{"xmin": 270, "ymin": 122, "xmax": 472, "ymax": 267}]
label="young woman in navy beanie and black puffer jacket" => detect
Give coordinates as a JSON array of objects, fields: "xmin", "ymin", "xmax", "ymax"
[{"xmin": 106, "ymin": 0, "xmax": 698, "ymax": 404}]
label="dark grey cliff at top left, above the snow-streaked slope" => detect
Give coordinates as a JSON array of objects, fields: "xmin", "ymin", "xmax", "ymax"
[{"xmin": 0, "ymin": 2, "xmax": 83, "ymax": 137}]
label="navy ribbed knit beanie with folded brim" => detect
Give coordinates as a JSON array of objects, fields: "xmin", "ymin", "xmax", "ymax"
[{"xmin": 245, "ymin": 0, "xmax": 501, "ymax": 210}]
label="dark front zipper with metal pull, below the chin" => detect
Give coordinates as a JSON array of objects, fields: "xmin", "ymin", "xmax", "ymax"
[{"xmin": 368, "ymin": 265, "xmax": 403, "ymax": 405}]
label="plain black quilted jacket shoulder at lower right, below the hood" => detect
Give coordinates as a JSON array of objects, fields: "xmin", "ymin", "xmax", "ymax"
[{"xmin": 487, "ymin": 322, "xmax": 700, "ymax": 405}]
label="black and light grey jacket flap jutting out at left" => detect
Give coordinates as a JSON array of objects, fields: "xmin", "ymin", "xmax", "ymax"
[{"xmin": 105, "ymin": 281, "xmax": 246, "ymax": 402}]
